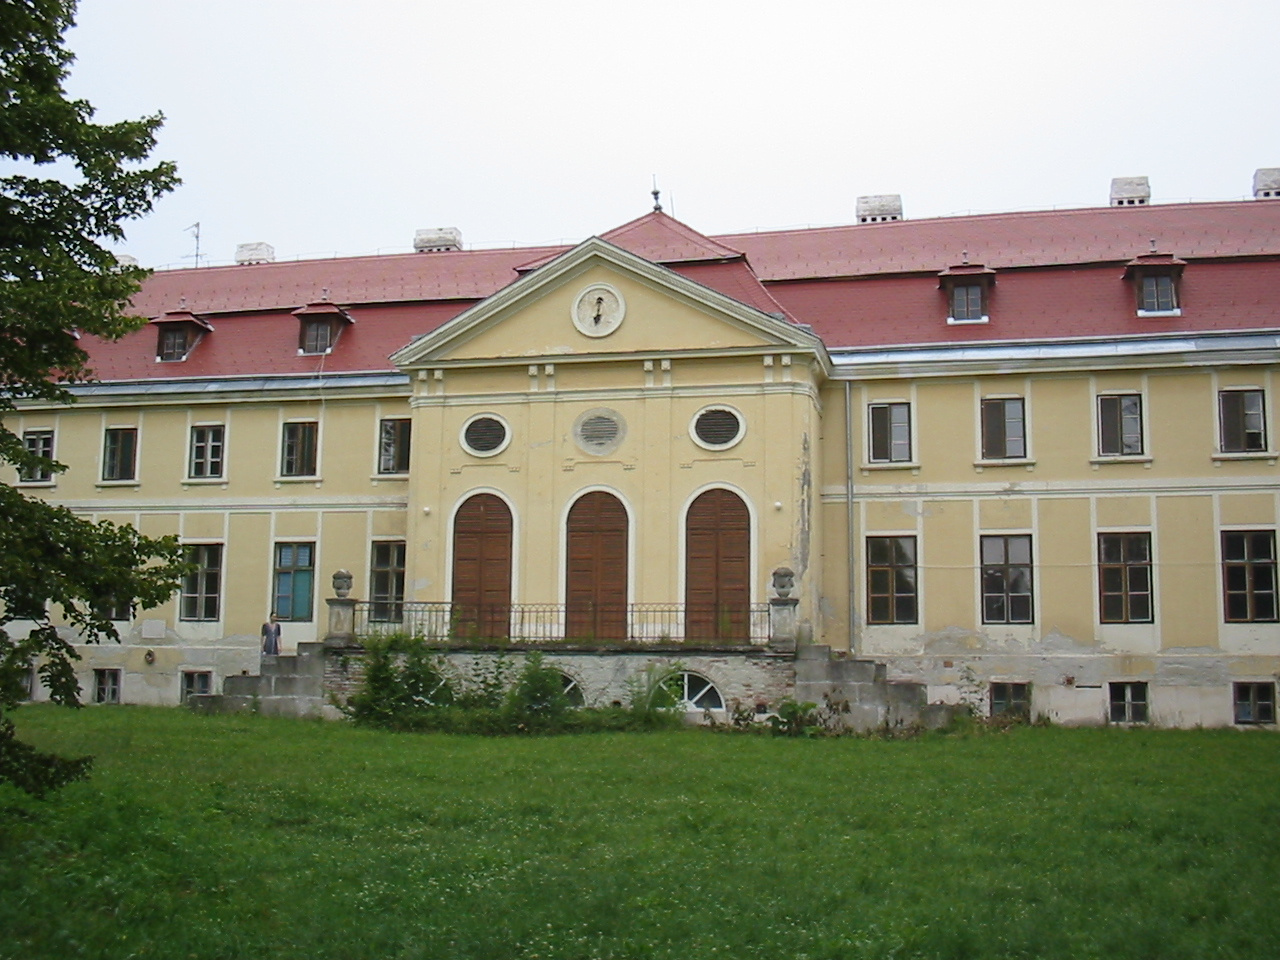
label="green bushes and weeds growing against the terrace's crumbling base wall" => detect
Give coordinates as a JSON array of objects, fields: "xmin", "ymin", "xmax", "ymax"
[{"xmin": 346, "ymin": 636, "xmax": 684, "ymax": 735}]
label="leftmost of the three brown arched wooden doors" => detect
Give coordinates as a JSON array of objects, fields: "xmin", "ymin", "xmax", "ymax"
[{"xmin": 453, "ymin": 493, "xmax": 512, "ymax": 640}]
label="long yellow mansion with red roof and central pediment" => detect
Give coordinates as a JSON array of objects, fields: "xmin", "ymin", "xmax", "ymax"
[{"xmin": 8, "ymin": 170, "xmax": 1280, "ymax": 726}]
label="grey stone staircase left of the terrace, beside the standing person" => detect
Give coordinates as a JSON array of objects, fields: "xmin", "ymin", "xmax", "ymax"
[{"xmin": 187, "ymin": 644, "xmax": 340, "ymax": 719}]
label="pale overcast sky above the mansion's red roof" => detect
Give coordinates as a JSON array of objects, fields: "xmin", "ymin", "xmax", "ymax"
[{"xmin": 68, "ymin": 0, "xmax": 1280, "ymax": 266}]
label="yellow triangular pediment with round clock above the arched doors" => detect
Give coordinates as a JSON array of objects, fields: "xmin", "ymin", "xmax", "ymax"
[{"xmin": 392, "ymin": 235, "xmax": 829, "ymax": 369}]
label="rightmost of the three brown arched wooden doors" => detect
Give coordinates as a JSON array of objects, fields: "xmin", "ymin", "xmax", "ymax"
[{"xmin": 685, "ymin": 489, "xmax": 751, "ymax": 643}]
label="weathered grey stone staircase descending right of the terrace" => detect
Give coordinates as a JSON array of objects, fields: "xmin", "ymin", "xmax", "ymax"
[{"xmin": 795, "ymin": 644, "xmax": 955, "ymax": 730}]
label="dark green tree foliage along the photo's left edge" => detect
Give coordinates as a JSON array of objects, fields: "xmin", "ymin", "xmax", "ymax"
[{"xmin": 0, "ymin": 0, "xmax": 180, "ymax": 795}]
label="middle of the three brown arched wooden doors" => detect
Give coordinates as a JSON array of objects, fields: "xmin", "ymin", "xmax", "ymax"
[{"xmin": 564, "ymin": 490, "xmax": 627, "ymax": 640}]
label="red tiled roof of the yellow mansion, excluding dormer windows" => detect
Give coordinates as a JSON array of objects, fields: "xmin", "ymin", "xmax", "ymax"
[{"xmin": 84, "ymin": 201, "xmax": 1280, "ymax": 380}]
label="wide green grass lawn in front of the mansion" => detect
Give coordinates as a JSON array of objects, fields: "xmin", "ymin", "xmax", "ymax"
[{"xmin": 0, "ymin": 707, "xmax": 1280, "ymax": 960}]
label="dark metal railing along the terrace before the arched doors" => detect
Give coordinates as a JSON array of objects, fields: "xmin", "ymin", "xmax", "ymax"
[{"xmin": 355, "ymin": 600, "xmax": 769, "ymax": 646}]
